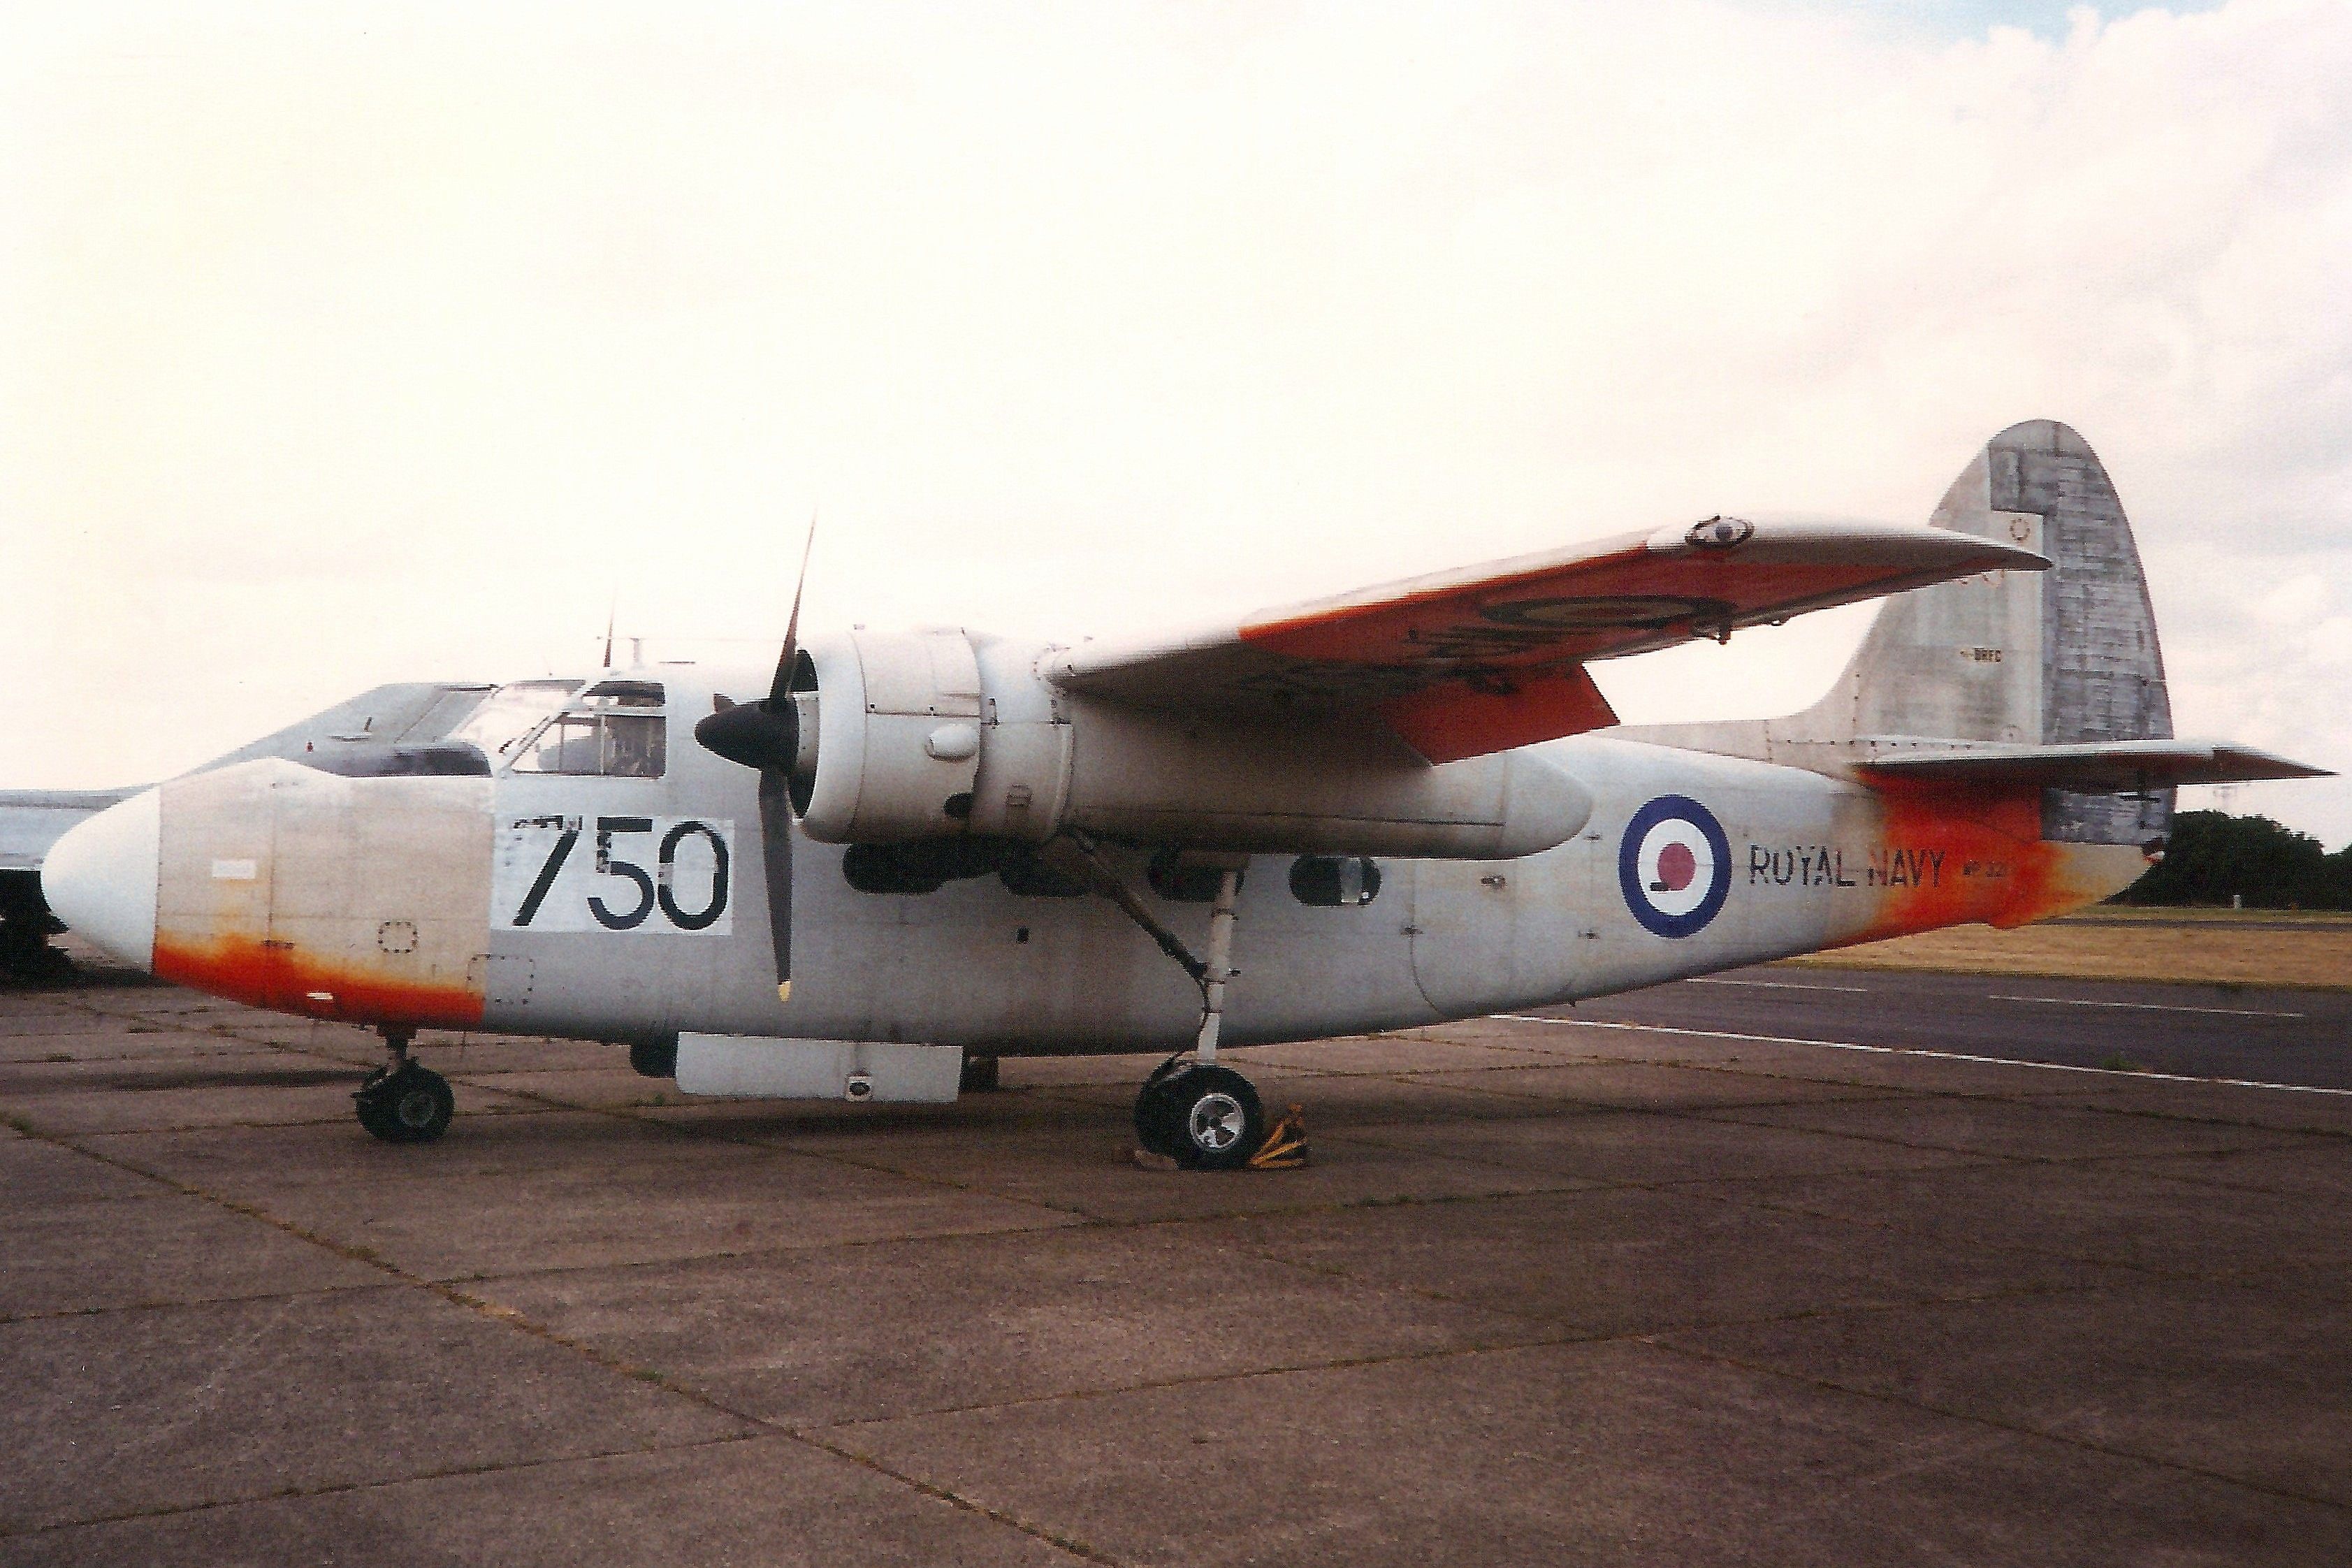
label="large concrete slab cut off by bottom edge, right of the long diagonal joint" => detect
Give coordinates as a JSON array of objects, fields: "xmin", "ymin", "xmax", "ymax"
[{"xmin": 837, "ymin": 1342, "xmax": 2352, "ymax": 1568}]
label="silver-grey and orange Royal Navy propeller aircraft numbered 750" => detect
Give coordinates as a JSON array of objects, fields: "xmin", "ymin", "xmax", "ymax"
[{"xmin": 40, "ymin": 421, "xmax": 2319, "ymax": 1168}]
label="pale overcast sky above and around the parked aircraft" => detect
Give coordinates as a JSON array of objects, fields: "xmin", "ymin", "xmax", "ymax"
[{"xmin": 0, "ymin": 0, "xmax": 2352, "ymax": 846}]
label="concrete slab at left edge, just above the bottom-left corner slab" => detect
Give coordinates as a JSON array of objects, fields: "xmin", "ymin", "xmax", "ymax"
[{"xmin": 0, "ymin": 1286, "xmax": 746, "ymax": 1530}]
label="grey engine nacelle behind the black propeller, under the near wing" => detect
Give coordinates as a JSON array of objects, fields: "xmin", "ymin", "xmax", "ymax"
[{"xmin": 795, "ymin": 630, "xmax": 1592, "ymax": 860}]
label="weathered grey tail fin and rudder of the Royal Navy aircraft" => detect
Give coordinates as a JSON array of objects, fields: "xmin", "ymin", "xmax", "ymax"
[{"xmin": 1792, "ymin": 419, "xmax": 2173, "ymax": 844}]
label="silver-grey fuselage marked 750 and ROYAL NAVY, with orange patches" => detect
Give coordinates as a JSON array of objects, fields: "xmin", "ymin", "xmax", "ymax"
[{"xmin": 124, "ymin": 665, "xmax": 2147, "ymax": 1056}]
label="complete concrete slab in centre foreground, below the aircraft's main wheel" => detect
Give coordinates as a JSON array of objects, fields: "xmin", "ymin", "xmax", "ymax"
[{"xmin": 475, "ymin": 1225, "xmax": 1543, "ymax": 1425}]
